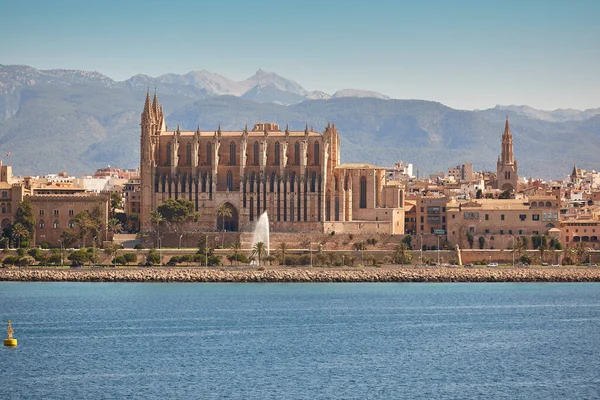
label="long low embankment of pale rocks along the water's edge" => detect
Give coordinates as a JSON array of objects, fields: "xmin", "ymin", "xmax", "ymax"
[{"xmin": 0, "ymin": 267, "xmax": 600, "ymax": 283}]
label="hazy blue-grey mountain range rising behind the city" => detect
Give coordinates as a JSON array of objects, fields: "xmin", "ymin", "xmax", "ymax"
[{"xmin": 0, "ymin": 65, "xmax": 600, "ymax": 179}]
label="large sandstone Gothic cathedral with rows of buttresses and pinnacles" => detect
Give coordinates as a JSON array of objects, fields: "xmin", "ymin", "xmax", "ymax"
[{"xmin": 140, "ymin": 93, "xmax": 404, "ymax": 234}]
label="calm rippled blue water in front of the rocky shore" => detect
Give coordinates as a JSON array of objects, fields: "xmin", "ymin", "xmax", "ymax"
[{"xmin": 0, "ymin": 283, "xmax": 600, "ymax": 400}]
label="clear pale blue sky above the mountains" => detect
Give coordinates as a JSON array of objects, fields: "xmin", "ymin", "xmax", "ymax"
[{"xmin": 0, "ymin": 0, "xmax": 600, "ymax": 110}]
